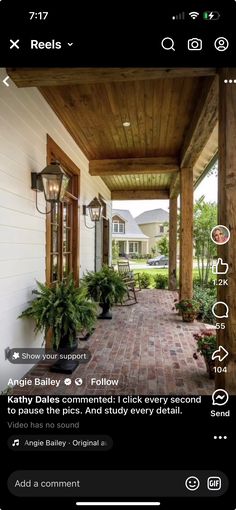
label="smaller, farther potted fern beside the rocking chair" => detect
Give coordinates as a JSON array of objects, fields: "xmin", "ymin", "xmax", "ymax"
[{"xmin": 83, "ymin": 266, "xmax": 127, "ymax": 319}]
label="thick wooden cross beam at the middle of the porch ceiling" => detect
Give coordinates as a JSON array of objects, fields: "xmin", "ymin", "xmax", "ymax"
[{"xmin": 89, "ymin": 157, "xmax": 179, "ymax": 176}]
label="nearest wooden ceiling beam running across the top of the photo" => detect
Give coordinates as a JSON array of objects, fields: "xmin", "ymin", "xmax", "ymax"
[{"xmin": 7, "ymin": 67, "xmax": 216, "ymax": 87}]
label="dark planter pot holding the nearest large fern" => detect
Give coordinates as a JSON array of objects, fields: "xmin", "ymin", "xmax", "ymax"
[{"xmin": 50, "ymin": 336, "xmax": 79, "ymax": 374}]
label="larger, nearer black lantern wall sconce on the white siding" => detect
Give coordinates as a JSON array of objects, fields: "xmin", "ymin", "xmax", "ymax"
[{"xmin": 31, "ymin": 161, "xmax": 70, "ymax": 214}]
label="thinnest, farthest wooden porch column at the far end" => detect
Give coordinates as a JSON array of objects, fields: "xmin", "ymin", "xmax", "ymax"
[{"xmin": 169, "ymin": 198, "xmax": 177, "ymax": 290}]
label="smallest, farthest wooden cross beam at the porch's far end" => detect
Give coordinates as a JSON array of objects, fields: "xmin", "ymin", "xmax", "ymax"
[{"xmin": 111, "ymin": 189, "xmax": 170, "ymax": 200}]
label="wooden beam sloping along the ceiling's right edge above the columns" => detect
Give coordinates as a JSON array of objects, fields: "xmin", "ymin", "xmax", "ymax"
[{"xmin": 180, "ymin": 77, "xmax": 218, "ymax": 168}]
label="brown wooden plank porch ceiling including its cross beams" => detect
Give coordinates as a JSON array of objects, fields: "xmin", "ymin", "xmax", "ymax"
[{"xmin": 8, "ymin": 68, "xmax": 218, "ymax": 198}]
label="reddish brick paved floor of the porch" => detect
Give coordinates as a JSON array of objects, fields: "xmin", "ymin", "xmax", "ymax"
[{"xmin": 14, "ymin": 289, "xmax": 214, "ymax": 395}]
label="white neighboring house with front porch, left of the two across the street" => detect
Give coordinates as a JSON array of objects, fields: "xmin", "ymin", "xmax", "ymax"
[{"xmin": 112, "ymin": 209, "xmax": 149, "ymax": 257}]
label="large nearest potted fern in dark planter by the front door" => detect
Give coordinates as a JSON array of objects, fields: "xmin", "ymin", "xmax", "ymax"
[{"xmin": 19, "ymin": 275, "xmax": 96, "ymax": 373}]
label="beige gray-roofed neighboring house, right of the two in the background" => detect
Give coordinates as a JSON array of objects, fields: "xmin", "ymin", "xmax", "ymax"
[{"xmin": 135, "ymin": 209, "xmax": 169, "ymax": 253}]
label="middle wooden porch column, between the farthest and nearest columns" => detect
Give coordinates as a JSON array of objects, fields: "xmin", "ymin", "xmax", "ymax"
[{"xmin": 179, "ymin": 168, "xmax": 193, "ymax": 299}]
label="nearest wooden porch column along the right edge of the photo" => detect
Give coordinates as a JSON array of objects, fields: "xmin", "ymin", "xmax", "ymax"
[{"xmin": 216, "ymin": 68, "xmax": 236, "ymax": 394}]
